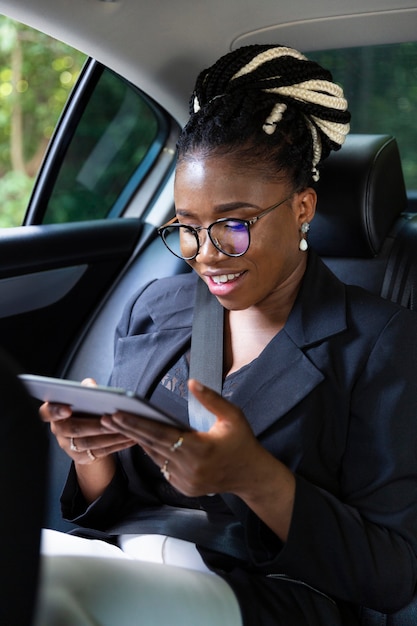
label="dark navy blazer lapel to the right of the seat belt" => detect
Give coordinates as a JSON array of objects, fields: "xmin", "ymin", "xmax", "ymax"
[{"xmin": 232, "ymin": 253, "xmax": 346, "ymax": 436}]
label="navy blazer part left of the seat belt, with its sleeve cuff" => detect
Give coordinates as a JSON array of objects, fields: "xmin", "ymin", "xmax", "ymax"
[{"xmin": 61, "ymin": 274, "xmax": 195, "ymax": 530}]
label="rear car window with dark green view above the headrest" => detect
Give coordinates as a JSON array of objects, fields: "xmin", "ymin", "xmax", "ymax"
[{"xmin": 309, "ymin": 43, "xmax": 417, "ymax": 190}]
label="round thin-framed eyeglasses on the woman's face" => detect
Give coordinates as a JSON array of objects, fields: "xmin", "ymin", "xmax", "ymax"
[{"xmin": 158, "ymin": 196, "xmax": 291, "ymax": 261}]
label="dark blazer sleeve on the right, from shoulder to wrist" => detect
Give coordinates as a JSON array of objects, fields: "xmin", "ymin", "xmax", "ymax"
[{"xmin": 245, "ymin": 310, "xmax": 417, "ymax": 613}]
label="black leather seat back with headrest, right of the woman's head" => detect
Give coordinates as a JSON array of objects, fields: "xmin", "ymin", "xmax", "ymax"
[{"xmin": 309, "ymin": 135, "xmax": 417, "ymax": 308}]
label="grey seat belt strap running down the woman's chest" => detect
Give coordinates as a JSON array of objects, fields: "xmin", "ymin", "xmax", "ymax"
[{"xmin": 188, "ymin": 279, "xmax": 224, "ymax": 432}]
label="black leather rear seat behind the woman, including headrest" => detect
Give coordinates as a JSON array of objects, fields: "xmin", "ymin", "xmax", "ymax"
[{"xmin": 44, "ymin": 135, "xmax": 417, "ymax": 626}]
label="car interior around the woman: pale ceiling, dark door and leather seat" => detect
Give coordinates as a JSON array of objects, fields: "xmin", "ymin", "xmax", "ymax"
[{"xmin": 0, "ymin": 0, "xmax": 417, "ymax": 626}]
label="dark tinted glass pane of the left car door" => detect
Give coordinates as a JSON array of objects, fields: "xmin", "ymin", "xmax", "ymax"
[{"xmin": 42, "ymin": 69, "xmax": 167, "ymax": 223}]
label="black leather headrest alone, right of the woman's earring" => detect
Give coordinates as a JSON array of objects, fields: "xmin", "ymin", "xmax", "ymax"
[{"xmin": 308, "ymin": 135, "xmax": 407, "ymax": 258}]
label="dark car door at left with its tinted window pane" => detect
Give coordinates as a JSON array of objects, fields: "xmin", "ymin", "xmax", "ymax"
[{"xmin": 0, "ymin": 59, "xmax": 178, "ymax": 375}]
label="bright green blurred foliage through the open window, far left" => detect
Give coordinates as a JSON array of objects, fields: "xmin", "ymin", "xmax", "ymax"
[{"xmin": 0, "ymin": 15, "xmax": 86, "ymax": 227}]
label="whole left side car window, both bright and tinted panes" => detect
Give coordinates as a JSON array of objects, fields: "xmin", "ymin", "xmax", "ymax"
[{"xmin": 0, "ymin": 15, "xmax": 173, "ymax": 228}]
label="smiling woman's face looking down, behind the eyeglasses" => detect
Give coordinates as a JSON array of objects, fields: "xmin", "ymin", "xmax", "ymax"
[{"xmin": 174, "ymin": 156, "xmax": 316, "ymax": 310}]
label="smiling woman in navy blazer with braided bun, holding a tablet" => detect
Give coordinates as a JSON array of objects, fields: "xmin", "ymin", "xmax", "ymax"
[{"xmin": 37, "ymin": 46, "xmax": 417, "ymax": 626}]
